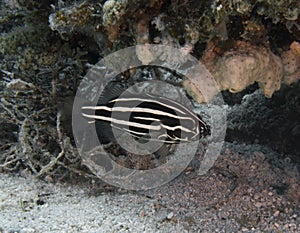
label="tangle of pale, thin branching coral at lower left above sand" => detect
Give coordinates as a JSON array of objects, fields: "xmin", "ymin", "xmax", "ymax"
[{"xmin": 0, "ymin": 73, "xmax": 84, "ymax": 176}]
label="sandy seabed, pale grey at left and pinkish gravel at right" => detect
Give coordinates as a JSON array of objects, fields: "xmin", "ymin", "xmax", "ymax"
[{"xmin": 0, "ymin": 143, "xmax": 300, "ymax": 232}]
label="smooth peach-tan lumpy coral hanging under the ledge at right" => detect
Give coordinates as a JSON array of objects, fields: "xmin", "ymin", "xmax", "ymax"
[{"xmin": 183, "ymin": 41, "xmax": 300, "ymax": 102}]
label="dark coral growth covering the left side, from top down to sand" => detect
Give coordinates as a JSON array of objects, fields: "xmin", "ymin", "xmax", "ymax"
[{"xmin": 0, "ymin": 0, "xmax": 88, "ymax": 176}]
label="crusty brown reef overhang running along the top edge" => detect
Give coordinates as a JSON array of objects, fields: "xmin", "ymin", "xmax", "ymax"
[{"xmin": 45, "ymin": 0, "xmax": 300, "ymax": 52}]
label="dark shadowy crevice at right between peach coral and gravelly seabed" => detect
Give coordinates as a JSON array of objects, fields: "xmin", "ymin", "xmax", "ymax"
[{"xmin": 225, "ymin": 83, "xmax": 300, "ymax": 162}]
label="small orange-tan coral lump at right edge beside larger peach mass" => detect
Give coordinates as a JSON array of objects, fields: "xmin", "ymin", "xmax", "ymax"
[{"xmin": 281, "ymin": 41, "xmax": 300, "ymax": 85}]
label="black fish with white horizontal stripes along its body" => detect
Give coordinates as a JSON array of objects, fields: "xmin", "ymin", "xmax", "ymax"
[{"xmin": 82, "ymin": 81, "xmax": 209, "ymax": 143}]
